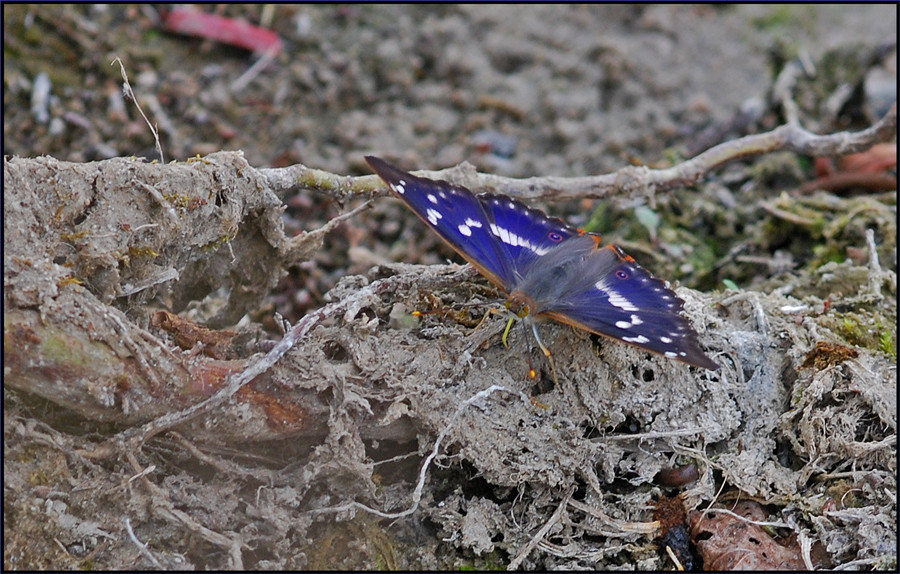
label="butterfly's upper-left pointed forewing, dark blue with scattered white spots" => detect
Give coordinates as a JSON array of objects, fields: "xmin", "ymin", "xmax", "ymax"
[{"xmin": 366, "ymin": 156, "xmax": 519, "ymax": 293}]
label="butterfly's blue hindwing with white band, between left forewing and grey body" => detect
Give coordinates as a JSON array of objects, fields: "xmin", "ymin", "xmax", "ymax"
[{"xmin": 478, "ymin": 193, "xmax": 581, "ymax": 275}]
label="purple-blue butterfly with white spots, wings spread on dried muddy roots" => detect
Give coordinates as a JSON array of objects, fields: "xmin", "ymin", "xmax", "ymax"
[{"xmin": 365, "ymin": 156, "xmax": 719, "ymax": 370}]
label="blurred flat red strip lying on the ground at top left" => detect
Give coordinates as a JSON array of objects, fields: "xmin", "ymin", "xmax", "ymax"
[{"xmin": 162, "ymin": 8, "xmax": 282, "ymax": 54}]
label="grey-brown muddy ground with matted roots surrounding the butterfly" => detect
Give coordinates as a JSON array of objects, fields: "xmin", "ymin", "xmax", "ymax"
[{"xmin": 3, "ymin": 5, "xmax": 897, "ymax": 569}]
